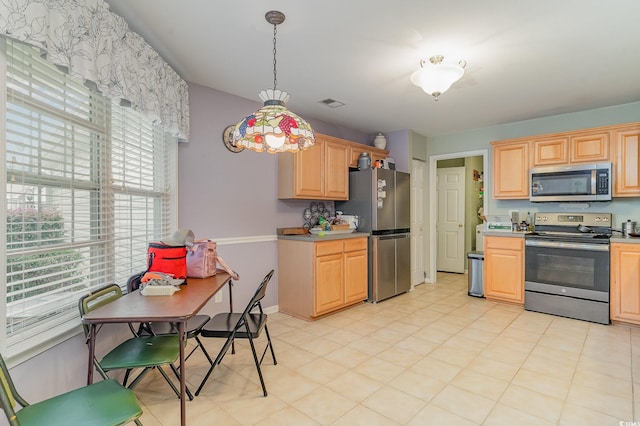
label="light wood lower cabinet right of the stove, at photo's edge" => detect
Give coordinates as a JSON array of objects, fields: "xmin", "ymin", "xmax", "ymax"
[{"xmin": 609, "ymin": 243, "xmax": 640, "ymax": 325}]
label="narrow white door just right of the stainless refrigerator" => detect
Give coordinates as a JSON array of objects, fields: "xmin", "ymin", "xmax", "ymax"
[{"xmin": 411, "ymin": 160, "xmax": 426, "ymax": 287}]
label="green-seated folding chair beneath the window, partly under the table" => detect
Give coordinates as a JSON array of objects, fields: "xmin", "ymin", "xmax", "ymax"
[{"xmin": 78, "ymin": 284, "xmax": 182, "ymax": 399}]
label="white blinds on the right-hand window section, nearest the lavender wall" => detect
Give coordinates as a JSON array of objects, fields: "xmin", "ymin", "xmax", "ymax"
[{"xmin": 109, "ymin": 103, "xmax": 177, "ymax": 282}]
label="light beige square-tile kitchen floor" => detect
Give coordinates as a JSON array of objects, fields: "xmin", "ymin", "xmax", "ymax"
[{"xmin": 136, "ymin": 273, "xmax": 640, "ymax": 426}]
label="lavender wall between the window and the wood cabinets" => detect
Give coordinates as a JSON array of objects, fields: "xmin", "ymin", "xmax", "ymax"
[{"xmin": 178, "ymin": 84, "xmax": 373, "ymax": 313}]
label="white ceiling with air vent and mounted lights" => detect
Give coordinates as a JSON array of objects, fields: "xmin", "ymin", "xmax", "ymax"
[{"xmin": 106, "ymin": 0, "xmax": 640, "ymax": 136}]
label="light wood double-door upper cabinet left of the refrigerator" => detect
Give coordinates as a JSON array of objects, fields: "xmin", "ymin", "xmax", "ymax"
[{"xmin": 278, "ymin": 133, "xmax": 349, "ymax": 200}]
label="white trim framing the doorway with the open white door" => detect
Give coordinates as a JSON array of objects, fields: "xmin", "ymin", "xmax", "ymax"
[{"xmin": 426, "ymin": 149, "xmax": 491, "ymax": 283}]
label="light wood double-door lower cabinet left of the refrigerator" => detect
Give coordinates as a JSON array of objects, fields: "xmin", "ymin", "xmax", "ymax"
[{"xmin": 278, "ymin": 237, "xmax": 368, "ymax": 319}]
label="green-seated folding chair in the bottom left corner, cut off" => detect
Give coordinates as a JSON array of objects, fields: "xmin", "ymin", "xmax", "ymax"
[{"xmin": 0, "ymin": 355, "xmax": 142, "ymax": 426}]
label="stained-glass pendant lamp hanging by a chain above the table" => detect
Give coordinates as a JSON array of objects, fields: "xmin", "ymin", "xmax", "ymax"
[{"xmin": 232, "ymin": 10, "xmax": 315, "ymax": 153}]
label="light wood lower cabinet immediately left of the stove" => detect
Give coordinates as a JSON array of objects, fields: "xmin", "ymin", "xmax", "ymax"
[{"xmin": 484, "ymin": 235, "xmax": 524, "ymax": 305}]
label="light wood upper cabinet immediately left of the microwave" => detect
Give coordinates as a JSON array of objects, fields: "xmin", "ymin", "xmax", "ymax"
[{"xmin": 491, "ymin": 141, "xmax": 529, "ymax": 199}]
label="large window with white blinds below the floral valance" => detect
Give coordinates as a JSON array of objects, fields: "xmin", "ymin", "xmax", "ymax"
[{"xmin": 0, "ymin": 39, "xmax": 177, "ymax": 355}]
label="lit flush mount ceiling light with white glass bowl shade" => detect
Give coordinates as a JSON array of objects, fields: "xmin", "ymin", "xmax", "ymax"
[{"xmin": 411, "ymin": 55, "xmax": 467, "ymax": 101}]
